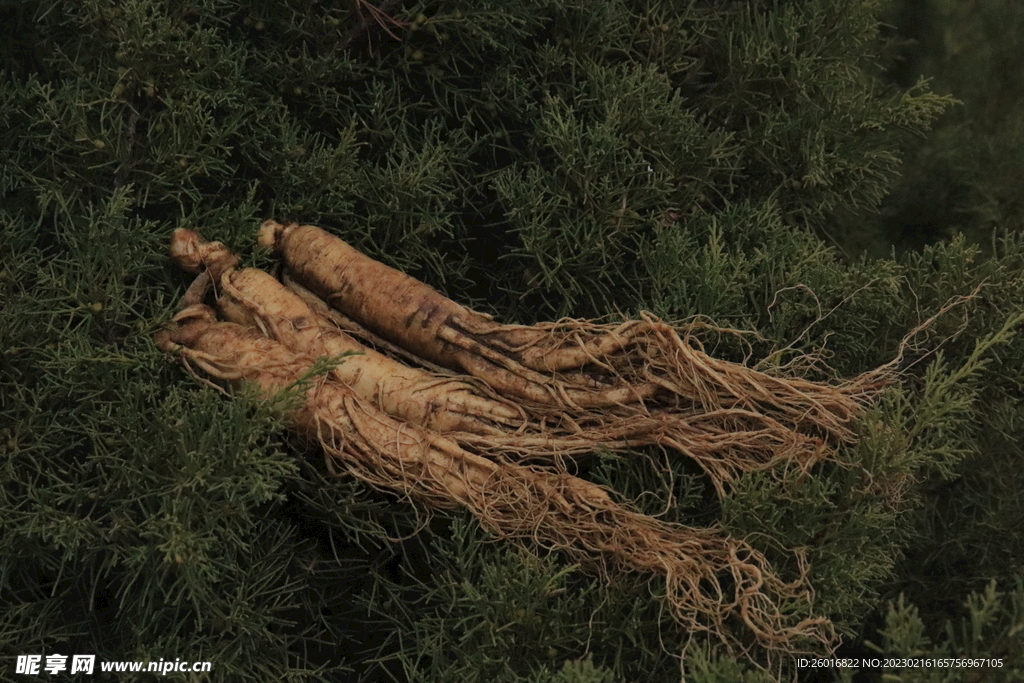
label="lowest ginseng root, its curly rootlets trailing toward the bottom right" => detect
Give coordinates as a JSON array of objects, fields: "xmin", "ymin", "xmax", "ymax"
[{"xmin": 156, "ymin": 299, "xmax": 835, "ymax": 652}]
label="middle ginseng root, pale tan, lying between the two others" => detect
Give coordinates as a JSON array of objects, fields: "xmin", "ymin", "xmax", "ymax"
[{"xmin": 171, "ymin": 229, "xmax": 826, "ymax": 495}]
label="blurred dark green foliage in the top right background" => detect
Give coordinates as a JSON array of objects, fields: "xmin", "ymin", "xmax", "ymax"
[{"xmin": 880, "ymin": 0, "xmax": 1024, "ymax": 250}]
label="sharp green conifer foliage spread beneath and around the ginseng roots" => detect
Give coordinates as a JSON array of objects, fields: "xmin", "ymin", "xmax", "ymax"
[{"xmin": 0, "ymin": 0, "xmax": 1024, "ymax": 683}]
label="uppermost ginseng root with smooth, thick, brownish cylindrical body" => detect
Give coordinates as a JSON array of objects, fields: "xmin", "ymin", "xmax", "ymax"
[{"xmin": 259, "ymin": 220, "xmax": 881, "ymax": 440}]
